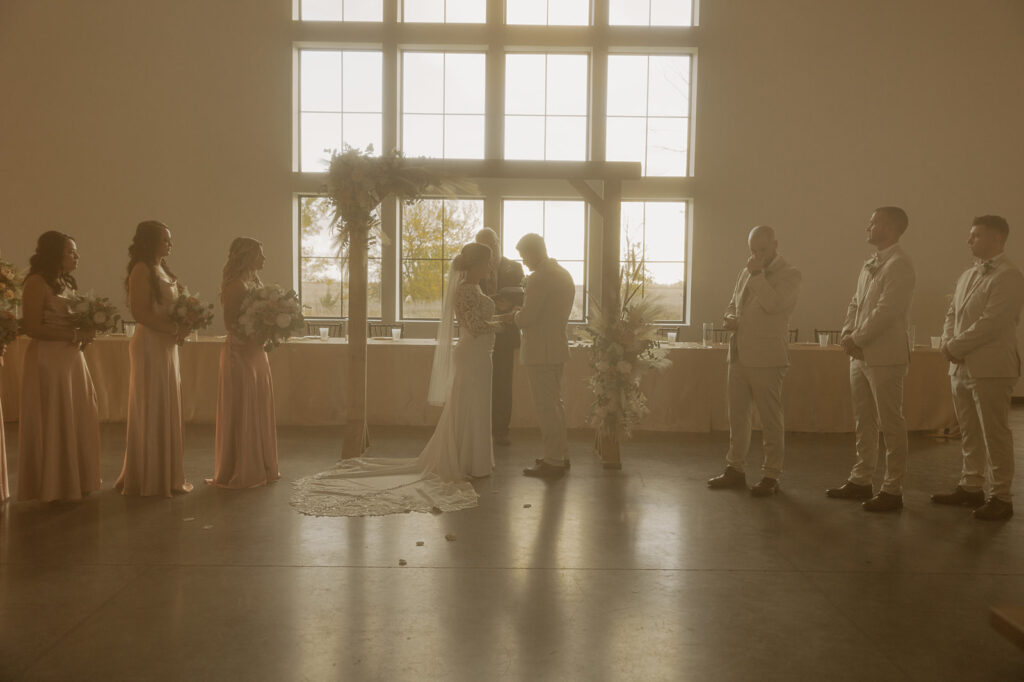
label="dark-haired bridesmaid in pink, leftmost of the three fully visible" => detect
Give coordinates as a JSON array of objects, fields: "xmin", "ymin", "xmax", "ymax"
[{"xmin": 17, "ymin": 231, "xmax": 99, "ymax": 502}]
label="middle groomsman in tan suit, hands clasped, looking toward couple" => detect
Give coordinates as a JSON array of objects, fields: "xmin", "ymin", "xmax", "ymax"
[{"xmin": 825, "ymin": 206, "xmax": 914, "ymax": 512}]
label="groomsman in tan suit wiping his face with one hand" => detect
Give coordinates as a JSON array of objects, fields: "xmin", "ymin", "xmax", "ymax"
[{"xmin": 708, "ymin": 225, "xmax": 801, "ymax": 497}]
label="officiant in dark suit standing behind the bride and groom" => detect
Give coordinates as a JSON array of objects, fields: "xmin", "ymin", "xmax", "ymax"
[{"xmin": 476, "ymin": 227, "xmax": 524, "ymax": 445}]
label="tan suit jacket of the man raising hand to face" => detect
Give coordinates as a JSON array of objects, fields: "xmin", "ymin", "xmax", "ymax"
[{"xmin": 725, "ymin": 255, "xmax": 801, "ymax": 367}]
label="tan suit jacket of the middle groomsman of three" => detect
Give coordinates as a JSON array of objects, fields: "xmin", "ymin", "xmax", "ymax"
[{"xmin": 843, "ymin": 244, "xmax": 915, "ymax": 366}]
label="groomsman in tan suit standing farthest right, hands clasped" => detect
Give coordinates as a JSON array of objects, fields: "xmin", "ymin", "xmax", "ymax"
[{"xmin": 932, "ymin": 215, "xmax": 1024, "ymax": 520}]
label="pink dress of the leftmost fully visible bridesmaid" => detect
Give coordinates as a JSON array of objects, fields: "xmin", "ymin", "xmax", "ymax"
[{"xmin": 17, "ymin": 287, "xmax": 99, "ymax": 502}]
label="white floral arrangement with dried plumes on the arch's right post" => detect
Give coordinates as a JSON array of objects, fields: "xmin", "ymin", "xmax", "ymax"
[{"xmin": 583, "ymin": 250, "xmax": 672, "ymax": 437}]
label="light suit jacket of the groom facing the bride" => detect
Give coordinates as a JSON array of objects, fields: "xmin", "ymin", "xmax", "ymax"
[{"xmin": 515, "ymin": 258, "xmax": 575, "ymax": 365}]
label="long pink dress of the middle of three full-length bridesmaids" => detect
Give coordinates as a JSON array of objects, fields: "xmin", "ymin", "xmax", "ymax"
[{"xmin": 114, "ymin": 280, "xmax": 193, "ymax": 497}]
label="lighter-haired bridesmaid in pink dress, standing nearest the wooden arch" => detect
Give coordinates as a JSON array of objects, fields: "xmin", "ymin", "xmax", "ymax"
[{"xmin": 206, "ymin": 237, "xmax": 281, "ymax": 488}]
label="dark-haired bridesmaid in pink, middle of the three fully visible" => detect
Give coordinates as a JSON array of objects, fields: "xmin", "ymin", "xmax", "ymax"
[{"xmin": 114, "ymin": 220, "xmax": 193, "ymax": 497}]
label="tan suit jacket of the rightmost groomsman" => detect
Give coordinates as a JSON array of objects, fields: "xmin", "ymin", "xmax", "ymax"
[{"xmin": 942, "ymin": 255, "xmax": 1024, "ymax": 379}]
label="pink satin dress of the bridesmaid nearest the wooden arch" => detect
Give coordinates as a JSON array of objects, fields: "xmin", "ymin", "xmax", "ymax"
[{"xmin": 206, "ymin": 278, "xmax": 281, "ymax": 488}]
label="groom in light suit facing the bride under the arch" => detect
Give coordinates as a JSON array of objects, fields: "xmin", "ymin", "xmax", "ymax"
[{"xmin": 515, "ymin": 233, "xmax": 575, "ymax": 478}]
